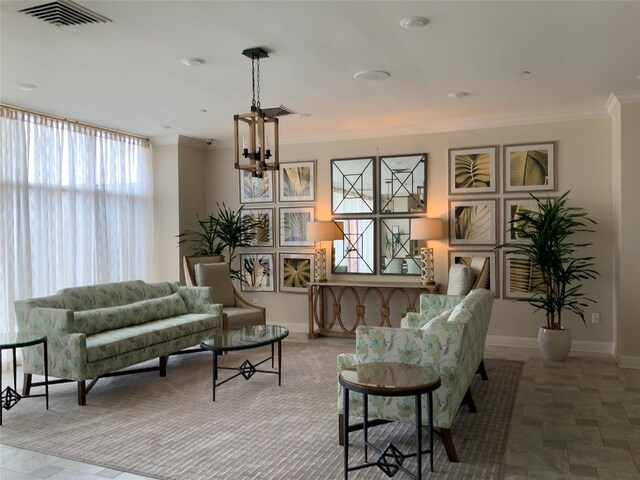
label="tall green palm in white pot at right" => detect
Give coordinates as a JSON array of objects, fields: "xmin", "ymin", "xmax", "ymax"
[{"xmin": 496, "ymin": 192, "xmax": 599, "ymax": 360}]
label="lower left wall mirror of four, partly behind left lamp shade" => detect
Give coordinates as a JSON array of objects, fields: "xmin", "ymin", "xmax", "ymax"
[{"xmin": 331, "ymin": 218, "xmax": 375, "ymax": 274}]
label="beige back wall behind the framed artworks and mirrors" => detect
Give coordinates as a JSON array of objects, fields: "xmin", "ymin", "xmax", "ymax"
[{"xmin": 206, "ymin": 118, "xmax": 614, "ymax": 350}]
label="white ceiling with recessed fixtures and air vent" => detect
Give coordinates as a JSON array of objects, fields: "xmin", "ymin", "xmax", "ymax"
[{"xmin": 0, "ymin": 0, "xmax": 640, "ymax": 144}]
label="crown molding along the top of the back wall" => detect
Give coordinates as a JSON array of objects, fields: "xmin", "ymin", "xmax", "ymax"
[{"xmin": 213, "ymin": 109, "xmax": 609, "ymax": 149}]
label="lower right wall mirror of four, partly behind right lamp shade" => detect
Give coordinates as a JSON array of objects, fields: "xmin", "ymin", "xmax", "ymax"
[{"xmin": 378, "ymin": 217, "xmax": 420, "ymax": 275}]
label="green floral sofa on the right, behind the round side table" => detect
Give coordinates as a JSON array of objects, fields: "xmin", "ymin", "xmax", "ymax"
[{"xmin": 338, "ymin": 289, "xmax": 493, "ymax": 462}]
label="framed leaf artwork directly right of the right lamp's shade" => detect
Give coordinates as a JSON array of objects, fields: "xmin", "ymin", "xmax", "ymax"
[{"xmin": 449, "ymin": 199, "xmax": 497, "ymax": 246}]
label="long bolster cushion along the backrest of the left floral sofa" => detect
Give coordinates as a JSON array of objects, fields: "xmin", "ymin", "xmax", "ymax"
[{"xmin": 74, "ymin": 293, "xmax": 187, "ymax": 335}]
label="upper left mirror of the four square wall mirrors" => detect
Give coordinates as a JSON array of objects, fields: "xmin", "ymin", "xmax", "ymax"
[{"xmin": 331, "ymin": 157, "xmax": 375, "ymax": 214}]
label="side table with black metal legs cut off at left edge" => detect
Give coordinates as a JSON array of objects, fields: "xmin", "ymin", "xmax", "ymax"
[{"xmin": 0, "ymin": 332, "xmax": 49, "ymax": 425}]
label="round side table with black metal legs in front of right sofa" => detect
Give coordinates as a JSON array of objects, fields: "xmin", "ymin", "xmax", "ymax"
[{"xmin": 338, "ymin": 362, "xmax": 440, "ymax": 480}]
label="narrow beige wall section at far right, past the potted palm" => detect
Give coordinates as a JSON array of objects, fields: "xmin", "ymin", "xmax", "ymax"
[{"xmin": 612, "ymin": 99, "xmax": 640, "ymax": 368}]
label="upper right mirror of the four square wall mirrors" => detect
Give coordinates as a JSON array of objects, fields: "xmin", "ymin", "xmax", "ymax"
[{"xmin": 379, "ymin": 153, "xmax": 427, "ymax": 214}]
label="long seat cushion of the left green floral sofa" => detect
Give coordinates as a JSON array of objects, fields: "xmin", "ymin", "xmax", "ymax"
[{"xmin": 87, "ymin": 313, "xmax": 219, "ymax": 363}]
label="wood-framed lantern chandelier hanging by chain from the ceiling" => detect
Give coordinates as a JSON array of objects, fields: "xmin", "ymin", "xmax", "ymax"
[{"xmin": 233, "ymin": 48, "xmax": 279, "ymax": 178}]
